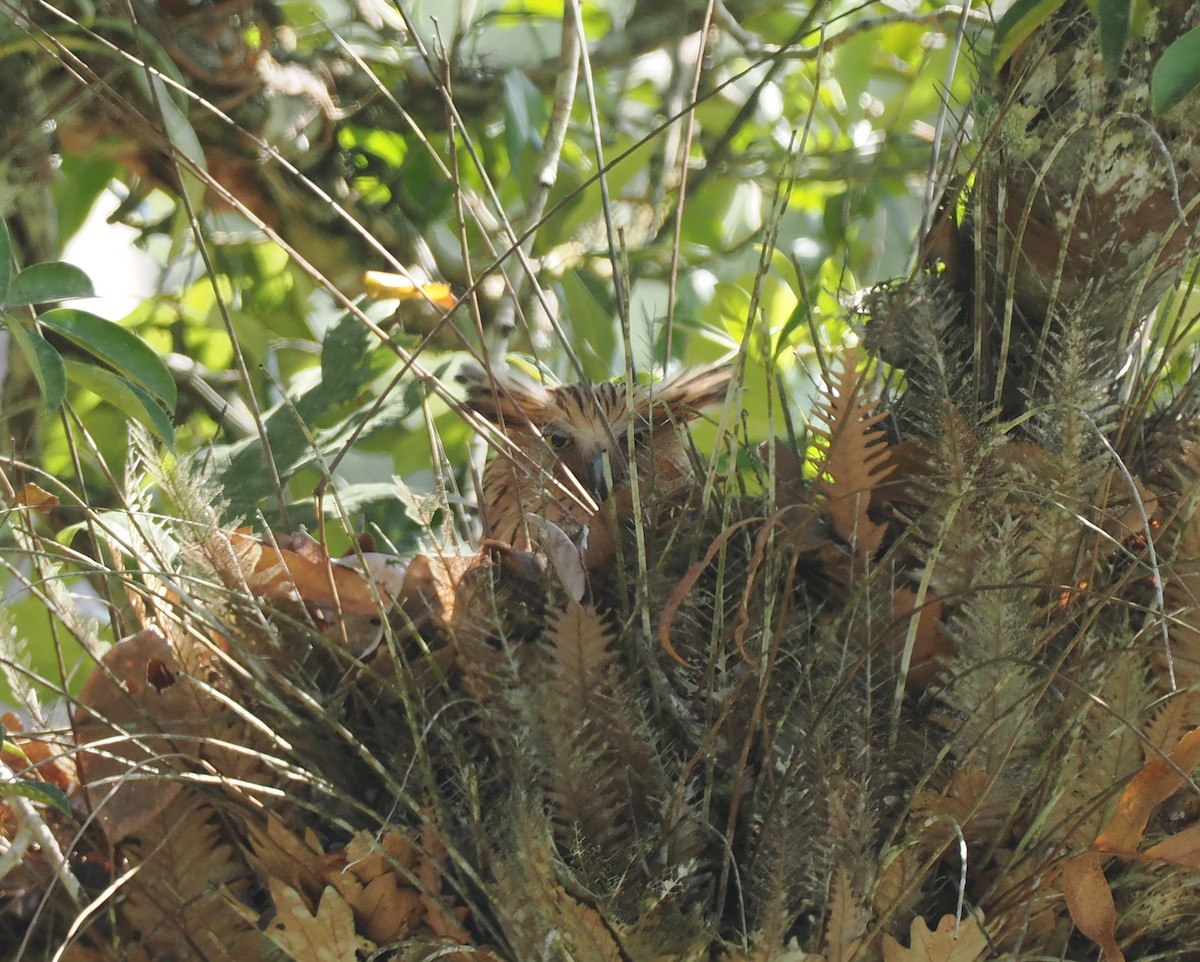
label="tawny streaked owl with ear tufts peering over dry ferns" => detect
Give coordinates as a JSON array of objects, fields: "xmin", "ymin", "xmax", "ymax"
[{"xmin": 458, "ymin": 366, "xmax": 731, "ymax": 548}]
